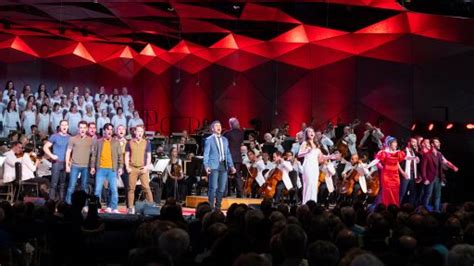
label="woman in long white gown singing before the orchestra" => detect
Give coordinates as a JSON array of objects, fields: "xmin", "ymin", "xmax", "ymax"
[{"xmin": 298, "ymin": 127, "xmax": 332, "ymax": 204}]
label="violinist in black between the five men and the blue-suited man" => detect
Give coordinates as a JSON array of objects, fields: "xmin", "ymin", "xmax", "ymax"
[{"xmin": 165, "ymin": 147, "xmax": 185, "ymax": 201}]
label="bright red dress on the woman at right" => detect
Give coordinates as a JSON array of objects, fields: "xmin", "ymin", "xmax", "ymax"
[{"xmin": 376, "ymin": 150, "xmax": 405, "ymax": 206}]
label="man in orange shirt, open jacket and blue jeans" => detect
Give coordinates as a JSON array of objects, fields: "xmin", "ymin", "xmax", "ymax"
[{"xmin": 90, "ymin": 123, "xmax": 123, "ymax": 213}]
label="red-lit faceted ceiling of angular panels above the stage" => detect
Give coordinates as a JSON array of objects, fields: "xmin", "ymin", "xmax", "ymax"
[{"xmin": 0, "ymin": 0, "xmax": 474, "ymax": 72}]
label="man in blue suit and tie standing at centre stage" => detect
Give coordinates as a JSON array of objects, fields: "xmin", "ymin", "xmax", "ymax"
[{"xmin": 203, "ymin": 121, "xmax": 235, "ymax": 210}]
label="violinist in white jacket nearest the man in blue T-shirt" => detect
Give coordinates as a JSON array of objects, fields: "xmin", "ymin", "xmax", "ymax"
[{"xmin": 21, "ymin": 143, "xmax": 49, "ymax": 198}]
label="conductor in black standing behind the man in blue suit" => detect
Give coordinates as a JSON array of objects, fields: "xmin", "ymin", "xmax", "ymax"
[{"xmin": 224, "ymin": 117, "xmax": 244, "ymax": 198}]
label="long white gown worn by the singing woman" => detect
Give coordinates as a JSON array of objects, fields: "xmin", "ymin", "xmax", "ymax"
[{"xmin": 303, "ymin": 149, "xmax": 321, "ymax": 204}]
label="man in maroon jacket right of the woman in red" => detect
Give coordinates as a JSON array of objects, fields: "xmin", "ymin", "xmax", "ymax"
[{"xmin": 421, "ymin": 140, "xmax": 444, "ymax": 212}]
